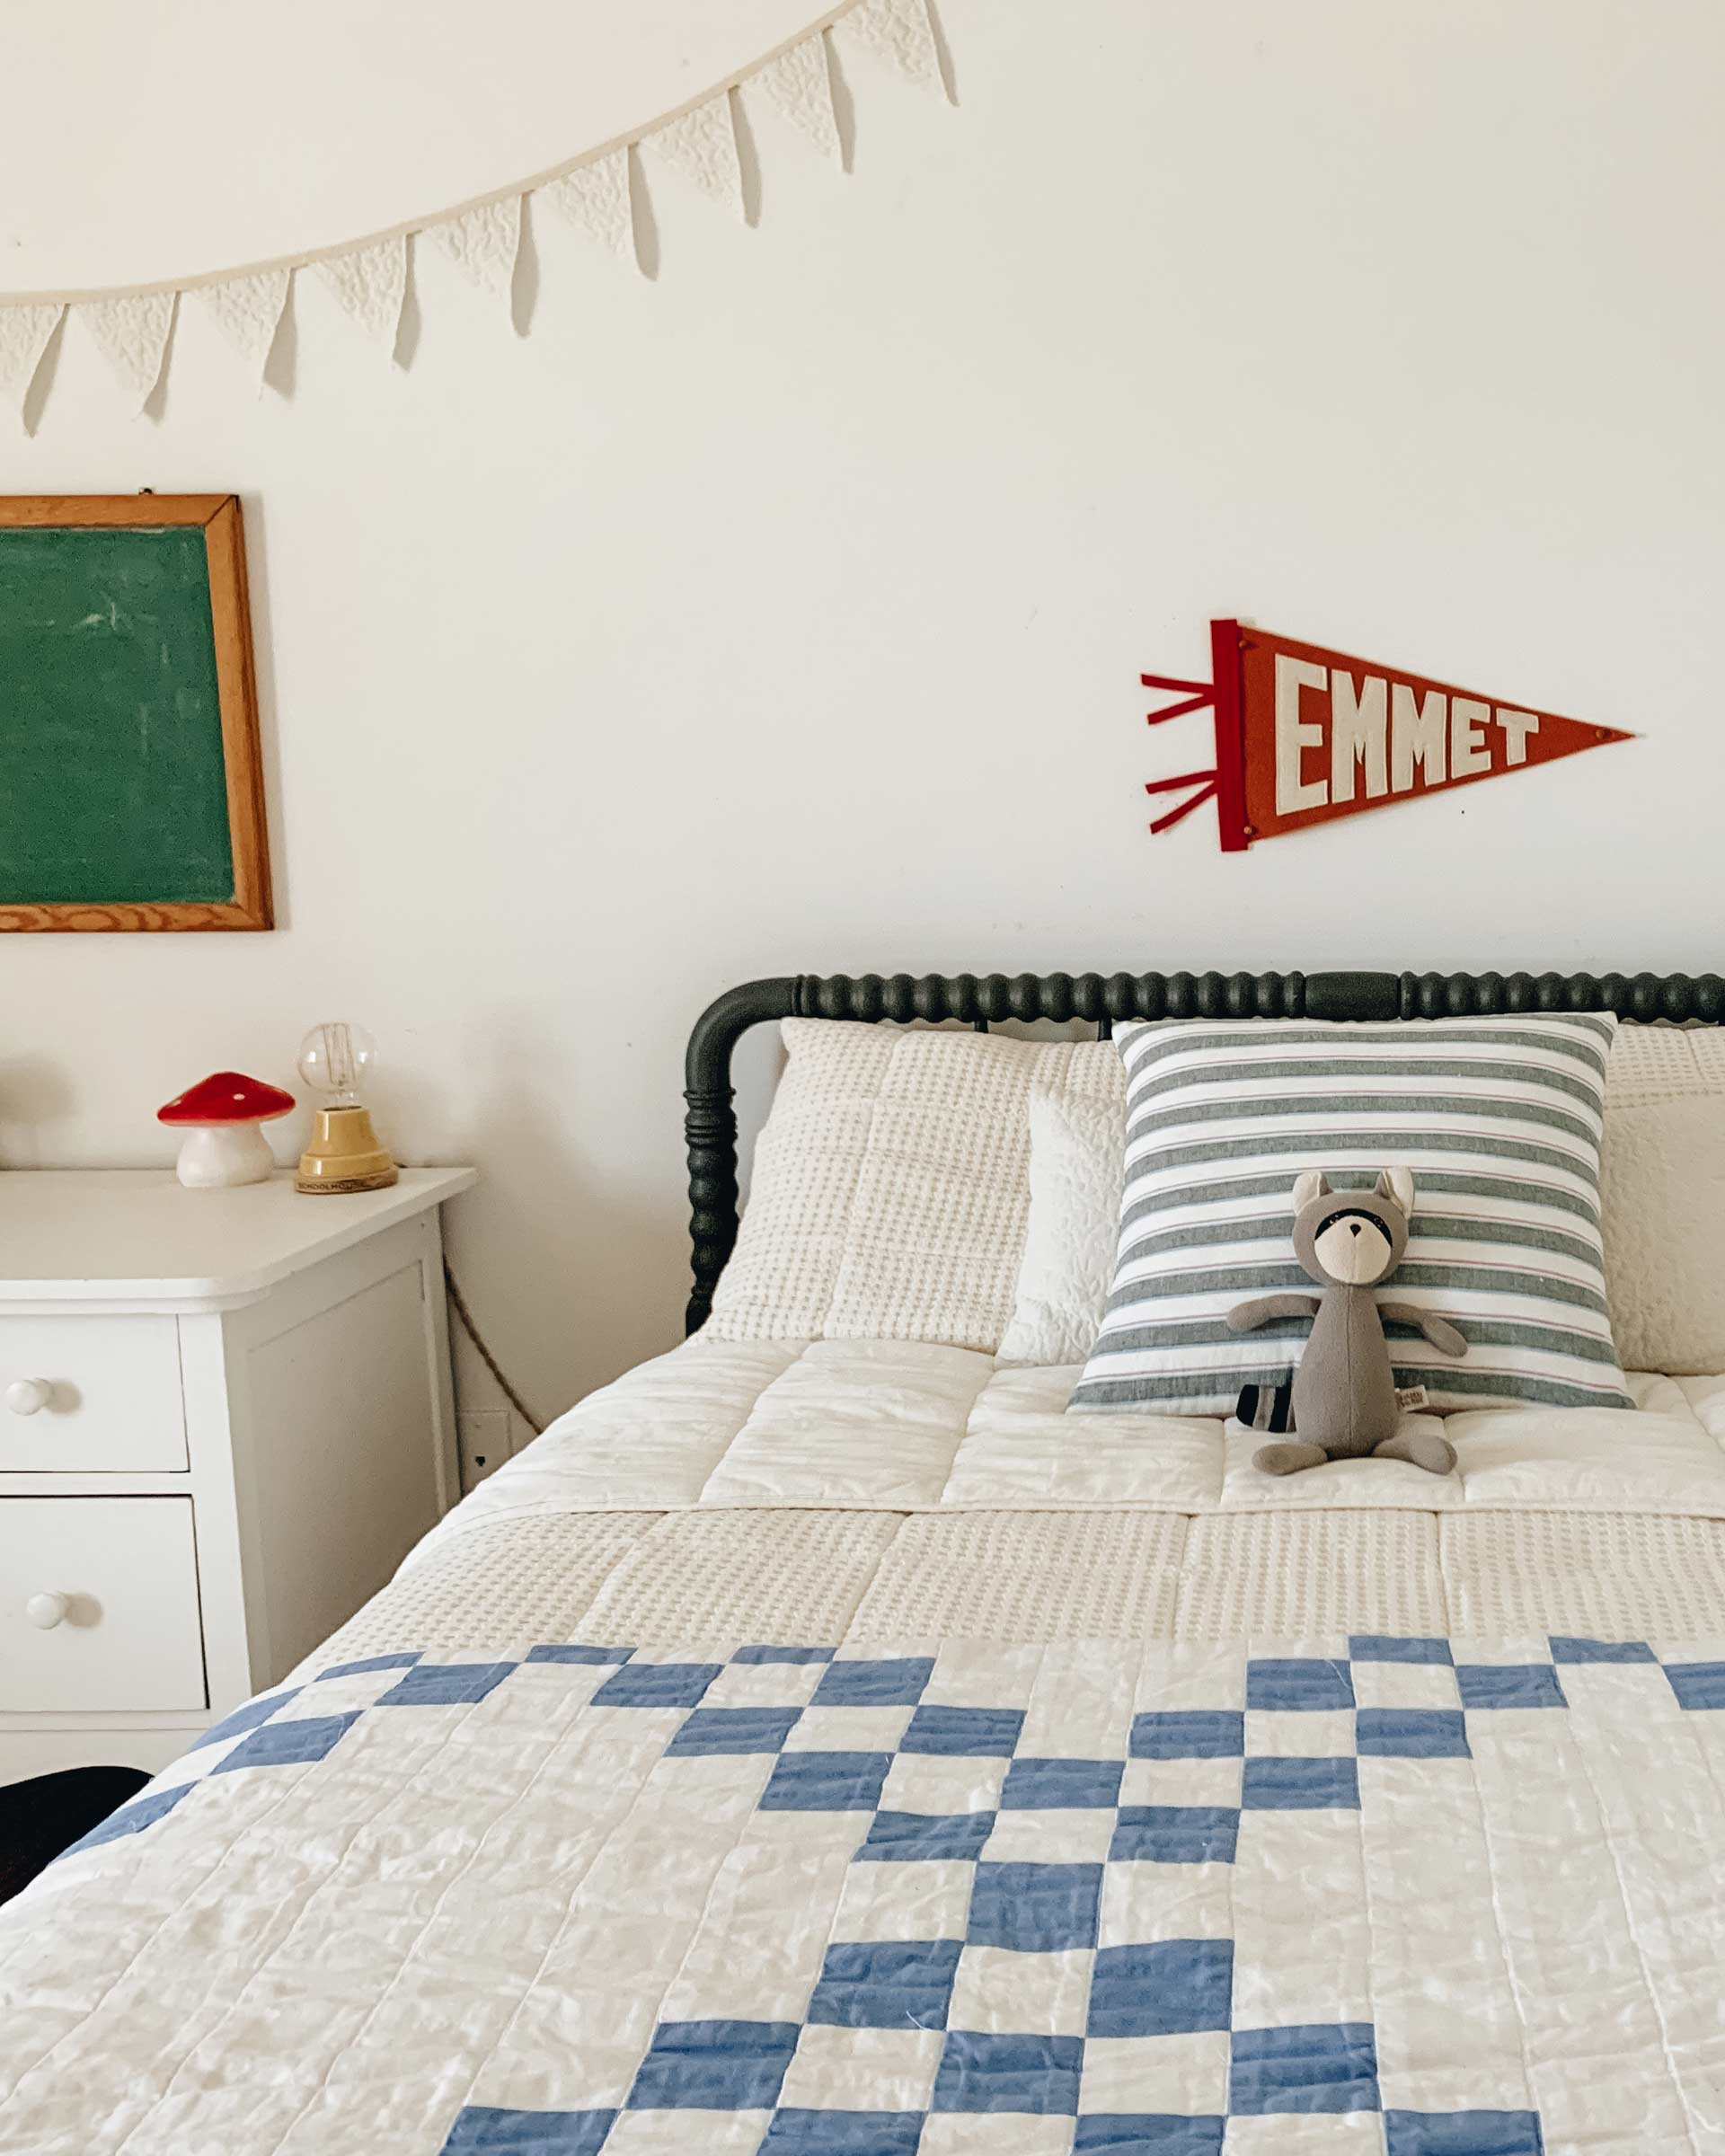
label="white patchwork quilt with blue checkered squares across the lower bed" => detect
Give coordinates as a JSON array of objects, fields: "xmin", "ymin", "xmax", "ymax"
[{"xmin": 0, "ymin": 1634, "xmax": 1725, "ymax": 2156}]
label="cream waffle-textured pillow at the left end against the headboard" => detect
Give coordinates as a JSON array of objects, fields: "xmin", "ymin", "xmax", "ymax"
[{"xmin": 710, "ymin": 1018, "xmax": 1098, "ymax": 1354}]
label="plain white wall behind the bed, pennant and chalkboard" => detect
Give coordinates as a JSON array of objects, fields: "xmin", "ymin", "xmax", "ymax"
[{"xmin": 0, "ymin": 0, "xmax": 1725, "ymax": 1440}]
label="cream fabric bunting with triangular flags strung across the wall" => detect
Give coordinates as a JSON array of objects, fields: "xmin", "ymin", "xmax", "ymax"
[{"xmin": 0, "ymin": 0, "xmax": 944, "ymax": 410}]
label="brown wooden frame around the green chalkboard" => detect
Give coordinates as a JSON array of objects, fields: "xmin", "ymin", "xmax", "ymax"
[{"xmin": 0, "ymin": 494, "xmax": 276, "ymax": 932}]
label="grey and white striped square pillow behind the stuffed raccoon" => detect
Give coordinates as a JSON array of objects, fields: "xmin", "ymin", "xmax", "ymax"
[{"xmin": 1072, "ymin": 1012, "xmax": 1632, "ymax": 1414}]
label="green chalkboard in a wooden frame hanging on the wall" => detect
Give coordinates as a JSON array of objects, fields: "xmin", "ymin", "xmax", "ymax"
[{"xmin": 0, "ymin": 496, "xmax": 268, "ymax": 944}]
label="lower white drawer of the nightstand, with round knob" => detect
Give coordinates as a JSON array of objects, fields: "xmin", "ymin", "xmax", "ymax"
[{"xmin": 0, "ymin": 1497, "xmax": 205, "ymax": 1714}]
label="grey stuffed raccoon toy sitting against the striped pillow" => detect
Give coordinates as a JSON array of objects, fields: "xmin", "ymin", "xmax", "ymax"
[{"xmin": 1227, "ymin": 1169, "xmax": 1468, "ymax": 1475}]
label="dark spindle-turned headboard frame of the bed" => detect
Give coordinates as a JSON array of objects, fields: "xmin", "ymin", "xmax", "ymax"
[{"xmin": 684, "ymin": 972, "xmax": 1725, "ymax": 1332}]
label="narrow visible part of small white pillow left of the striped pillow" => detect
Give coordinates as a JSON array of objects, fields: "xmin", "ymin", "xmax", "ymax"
[{"xmin": 1001, "ymin": 1086, "xmax": 1126, "ymax": 1365}]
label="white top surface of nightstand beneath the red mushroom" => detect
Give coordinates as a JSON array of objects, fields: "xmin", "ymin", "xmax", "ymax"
[{"xmin": 0, "ymin": 1169, "xmax": 479, "ymax": 1309}]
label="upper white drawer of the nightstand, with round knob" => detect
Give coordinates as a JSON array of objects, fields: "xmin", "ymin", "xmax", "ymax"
[{"xmin": 0, "ymin": 1317, "xmax": 185, "ymax": 1489}]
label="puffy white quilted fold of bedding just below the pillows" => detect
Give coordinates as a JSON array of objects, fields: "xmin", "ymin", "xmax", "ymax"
[{"xmin": 420, "ymin": 1335, "xmax": 1725, "ymax": 1543}]
